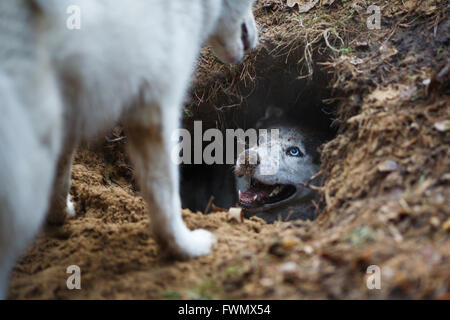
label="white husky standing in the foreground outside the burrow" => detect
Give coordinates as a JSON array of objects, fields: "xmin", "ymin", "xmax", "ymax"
[{"xmin": 0, "ymin": 0, "xmax": 257, "ymax": 297}]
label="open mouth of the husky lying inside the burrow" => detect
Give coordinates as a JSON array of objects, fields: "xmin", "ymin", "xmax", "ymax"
[{"xmin": 239, "ymin": 179, "xmax": 297, "ymax": 209}]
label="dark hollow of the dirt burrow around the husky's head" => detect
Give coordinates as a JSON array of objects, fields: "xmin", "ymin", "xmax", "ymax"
[{"xmin": 181, "ymin": 43, "xmax": 337, "ymax": 221}]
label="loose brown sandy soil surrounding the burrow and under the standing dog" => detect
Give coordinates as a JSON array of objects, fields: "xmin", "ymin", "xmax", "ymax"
[{"xmin": 9, "ymin": 0, "xmax": 450, "ymax": 299}]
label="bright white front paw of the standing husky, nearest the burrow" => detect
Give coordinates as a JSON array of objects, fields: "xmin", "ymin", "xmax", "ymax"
[{"xmin": 180, "ymin": 229, "xmax": 217, "ymax": 258}]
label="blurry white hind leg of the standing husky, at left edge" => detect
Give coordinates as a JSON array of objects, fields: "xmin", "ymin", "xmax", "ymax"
[{"xmin": 0, "ymin": 67, "xmax": 61, "ymax": 298}]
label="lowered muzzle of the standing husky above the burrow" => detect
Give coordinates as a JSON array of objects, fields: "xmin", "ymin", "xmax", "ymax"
[{"xmin": 208, "ymin": 0, "xmax": 258, "ymax": 63}]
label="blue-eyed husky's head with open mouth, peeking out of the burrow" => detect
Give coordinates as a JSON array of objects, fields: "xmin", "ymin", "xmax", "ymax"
[{"xmin": 235, "ymin": 107, "xmax": 321, "ymax": 223}]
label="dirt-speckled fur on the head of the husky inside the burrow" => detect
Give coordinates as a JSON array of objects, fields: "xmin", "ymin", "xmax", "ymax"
[{"xmin": 235, "ymin": 108, "xmax": 319, "ymax": 222}]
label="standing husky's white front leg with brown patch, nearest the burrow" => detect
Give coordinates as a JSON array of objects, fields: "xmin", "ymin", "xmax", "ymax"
[{"xmin": 127, "ymin": 106, "xmax": 215, "ymax": 258}]
